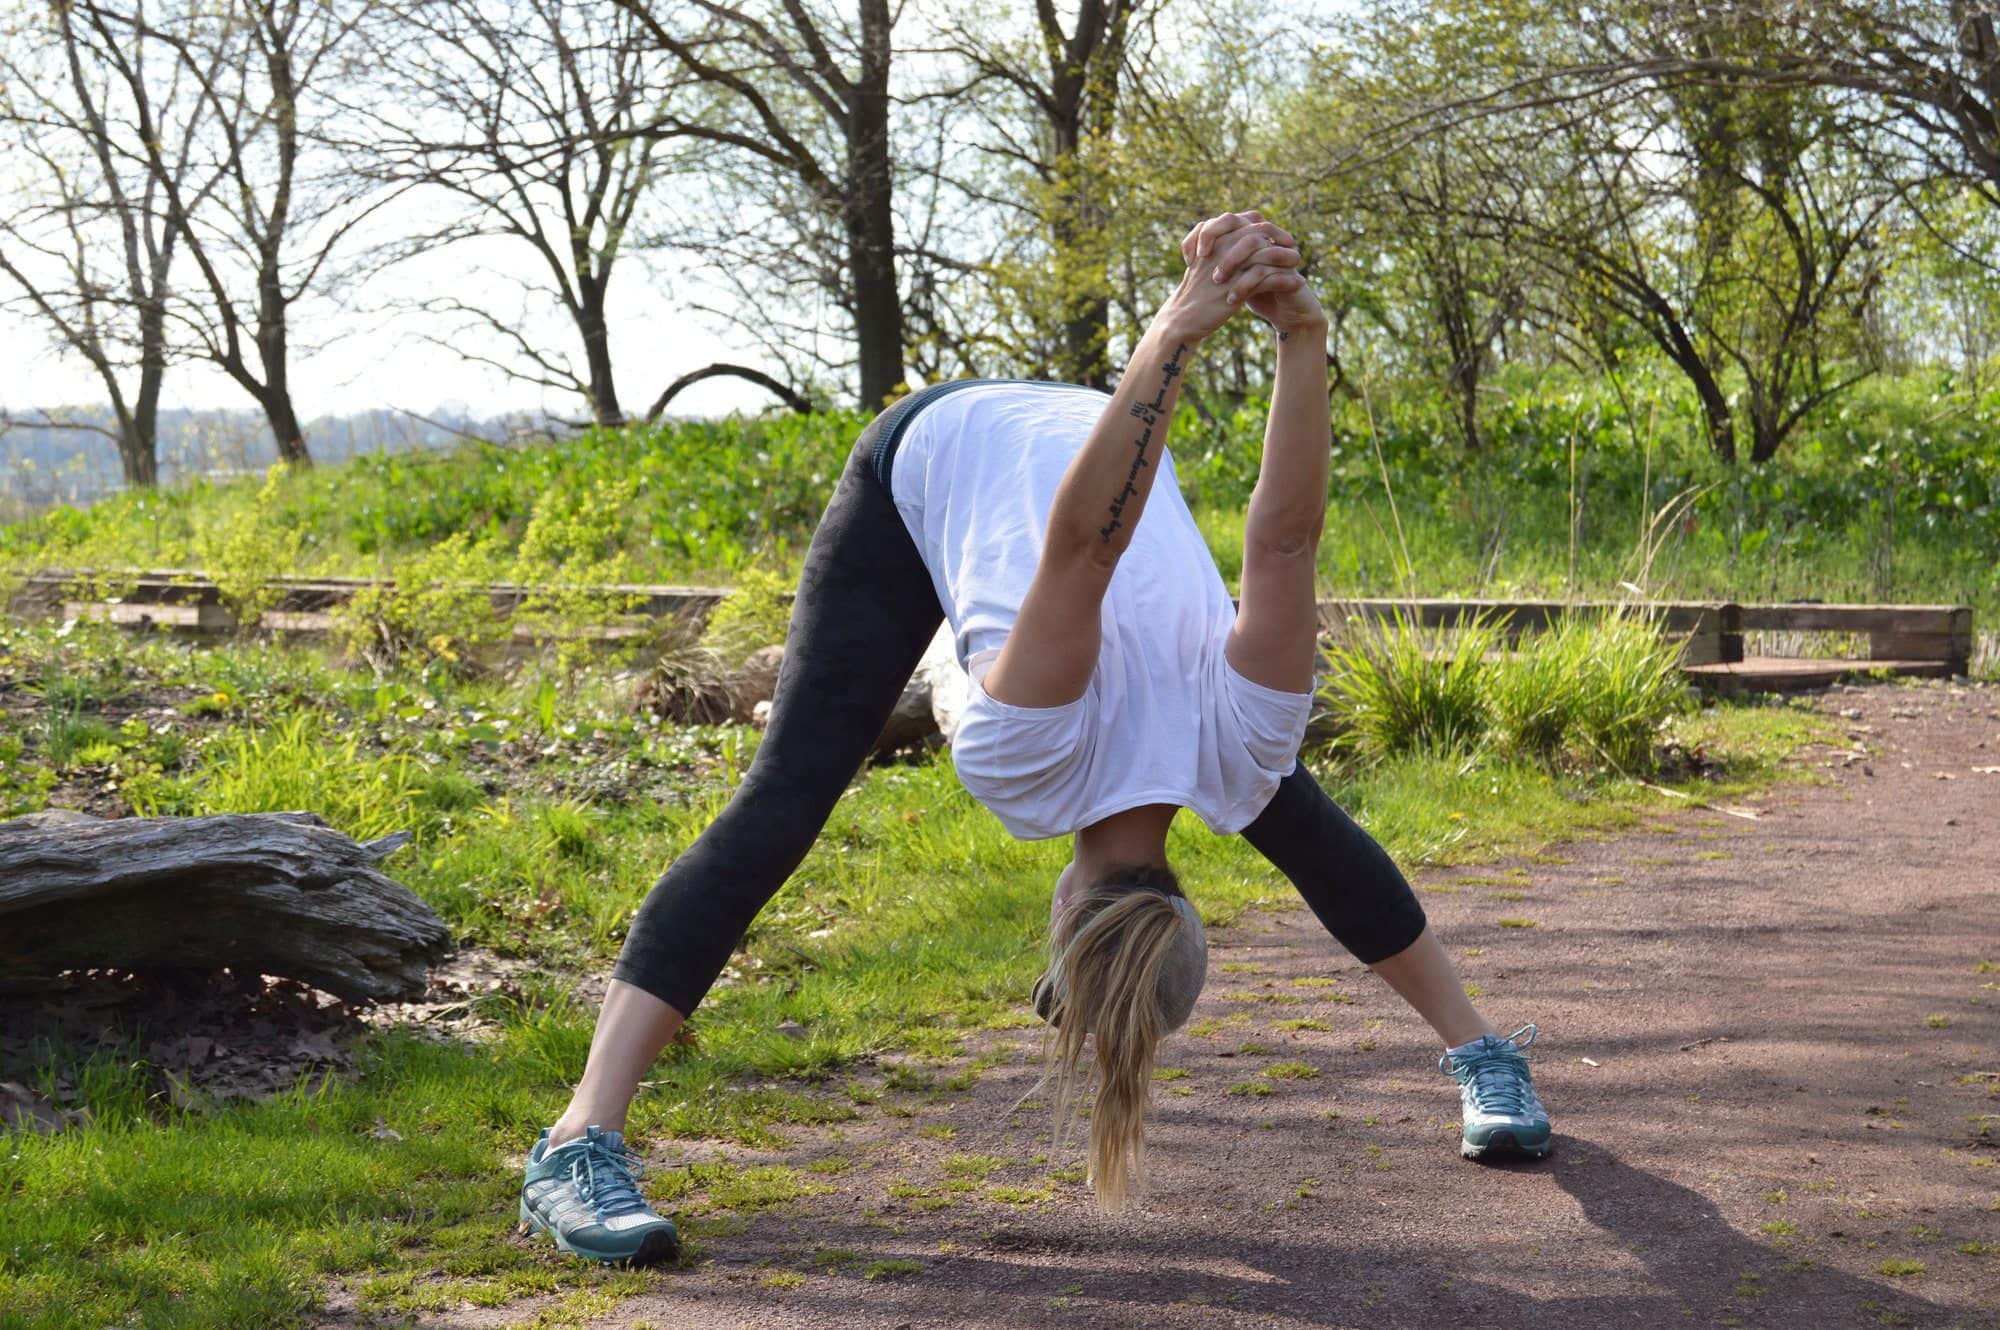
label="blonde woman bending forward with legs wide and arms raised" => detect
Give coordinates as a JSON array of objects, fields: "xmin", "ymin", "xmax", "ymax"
[{"xmin": 520, "ymin": 212, "xmax": 1550, "ymax": 1264}]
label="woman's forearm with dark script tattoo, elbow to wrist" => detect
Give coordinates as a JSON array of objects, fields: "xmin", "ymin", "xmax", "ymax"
[{"xmin": 1046, "ymin": 314, "xmax": 1202, "ymax": 566}]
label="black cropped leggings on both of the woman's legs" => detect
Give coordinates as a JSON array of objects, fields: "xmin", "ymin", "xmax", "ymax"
[{"xmin": 614, "ymin": 384, "xmax": 1424, "ymax": 1016}]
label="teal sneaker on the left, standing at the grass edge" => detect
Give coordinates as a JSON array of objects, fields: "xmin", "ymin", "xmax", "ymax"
[{"xmin": 520, "ymin": 1128, "xmax": 680, "ymax": 1266}]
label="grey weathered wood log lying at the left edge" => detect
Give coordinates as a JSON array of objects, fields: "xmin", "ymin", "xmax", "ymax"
[{"xmin": 0, "ymin": 812, "xmax": 452, "ymax": 1002}]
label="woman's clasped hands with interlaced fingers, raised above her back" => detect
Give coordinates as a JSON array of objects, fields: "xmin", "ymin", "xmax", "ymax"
[{"xmin": 1162, "ymin": 212, "xmax": 1326, "ymax": 338}]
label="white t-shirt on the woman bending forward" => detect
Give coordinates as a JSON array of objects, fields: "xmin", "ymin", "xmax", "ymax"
[{"xmin": 890, "ymin": 384, "xmax": 1312, "ymax": 840}]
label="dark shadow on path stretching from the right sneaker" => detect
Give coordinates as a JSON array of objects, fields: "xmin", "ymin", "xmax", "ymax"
[{"xmin": 1548, "ymin": 1136, "xmax": 1968, "ymax": 1330}]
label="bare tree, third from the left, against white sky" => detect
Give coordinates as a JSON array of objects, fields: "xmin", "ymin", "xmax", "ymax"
[{"xmin": 366, "ymin": 0, "xmax": 676, "ymax": 424}]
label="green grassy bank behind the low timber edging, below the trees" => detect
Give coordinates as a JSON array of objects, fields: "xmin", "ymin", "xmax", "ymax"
[{"xmin": 0, "ymin": 370, "xmax": 2000, "ymax": 644}]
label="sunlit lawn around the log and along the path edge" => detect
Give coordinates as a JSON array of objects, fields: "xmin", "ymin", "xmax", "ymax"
[{"xmin": 0, "ymin": 620, "xmax": 1824, "ymax": 1330}]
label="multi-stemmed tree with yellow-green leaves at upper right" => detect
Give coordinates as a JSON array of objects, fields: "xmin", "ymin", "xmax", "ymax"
[{"xmin": 1328, "ymin": 0, "xmax": 1894, "ymax": 462}]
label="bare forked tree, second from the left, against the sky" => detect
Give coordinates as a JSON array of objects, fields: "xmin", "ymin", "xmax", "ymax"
[{"xmin": 86, "ymin": 0, "xmax": 388, "ymax": 466}]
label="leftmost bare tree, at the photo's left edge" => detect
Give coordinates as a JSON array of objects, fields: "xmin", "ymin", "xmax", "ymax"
[{"xmin": 0, "ymin": 4, "xmax": 206, "ymax": 486}]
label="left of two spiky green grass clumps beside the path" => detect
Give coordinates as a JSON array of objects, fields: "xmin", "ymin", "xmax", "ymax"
[{"xmin": 1322, "ymin": 614, "xmax": 1500, "ymax": 760}]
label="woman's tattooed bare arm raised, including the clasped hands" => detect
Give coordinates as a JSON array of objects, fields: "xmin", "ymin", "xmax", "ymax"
[{"xmin": 984, "ymin": 212, "xmax": 1324, "ymax": 706}]
